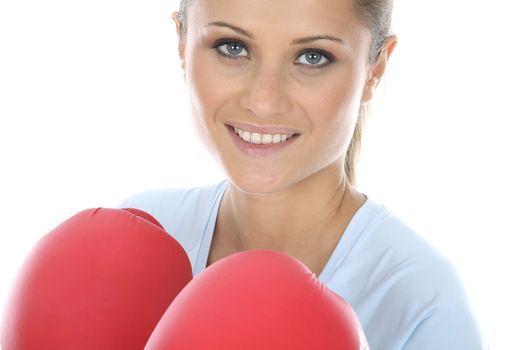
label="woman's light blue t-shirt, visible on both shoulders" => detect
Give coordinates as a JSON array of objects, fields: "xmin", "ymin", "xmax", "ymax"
[{"xmin": 121, "ymin": 181, "xmax": 486, "ymax": 350}]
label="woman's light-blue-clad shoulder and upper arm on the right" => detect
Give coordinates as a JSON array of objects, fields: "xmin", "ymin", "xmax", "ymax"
[{"xmin": 334, "ymin": 201, "xmax": 482, "ymax": 350}]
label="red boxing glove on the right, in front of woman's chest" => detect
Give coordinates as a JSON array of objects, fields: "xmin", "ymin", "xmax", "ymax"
[{"xmin": 145, "ymin": 250, "xmax": 368, "ymax": 350}]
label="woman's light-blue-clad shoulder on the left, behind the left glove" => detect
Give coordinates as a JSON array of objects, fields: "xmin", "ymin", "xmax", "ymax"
[{"xmin": 119, "ymin": 181, "xmax": 227, "ymax": 251}]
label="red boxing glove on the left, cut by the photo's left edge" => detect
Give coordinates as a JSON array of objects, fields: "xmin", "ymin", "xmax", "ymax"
[{"xmin": 1, "ymin": 209, "xmax": 192, "ymax": 350}]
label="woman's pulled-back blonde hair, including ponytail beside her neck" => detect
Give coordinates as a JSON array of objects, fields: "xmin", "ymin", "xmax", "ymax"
[{"xmin": 179, "ymin": 0, "xmax": 393, "ymax": 186}]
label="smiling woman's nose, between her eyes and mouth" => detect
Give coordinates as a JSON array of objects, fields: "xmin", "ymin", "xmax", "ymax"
[{"xmin": 240, "ymin": 65, "xmax": 292, "ymax": 118}]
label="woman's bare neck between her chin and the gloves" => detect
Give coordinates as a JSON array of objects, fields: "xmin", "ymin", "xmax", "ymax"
[{"xmin": 218, "ymin": 162, "xmax": 365, "ymax": 269}]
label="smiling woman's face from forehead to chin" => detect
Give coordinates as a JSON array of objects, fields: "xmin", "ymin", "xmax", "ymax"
[{"xmin": 181, "ymin": 0, "xmax": 371, "ymax": 193}]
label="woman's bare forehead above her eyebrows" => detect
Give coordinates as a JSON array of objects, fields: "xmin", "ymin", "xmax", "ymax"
[{"xmin": 188, "ymin": 0, "xmax": 369, "ymax": 43}]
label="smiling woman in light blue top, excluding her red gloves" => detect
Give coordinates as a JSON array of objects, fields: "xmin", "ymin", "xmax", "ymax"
[{"xmin": 122, "ymin": 0, "xmax": 483, "ymax": 350}]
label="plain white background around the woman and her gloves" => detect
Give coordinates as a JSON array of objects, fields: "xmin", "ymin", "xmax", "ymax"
[{"xmin": 0, "ymin": 0, "xmax": 525, "ymax": 349}]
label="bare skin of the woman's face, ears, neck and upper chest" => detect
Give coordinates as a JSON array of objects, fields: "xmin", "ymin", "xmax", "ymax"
[{"xmin": 174, "ymin": 0, "xmax": 396, "ymax": 275}]
